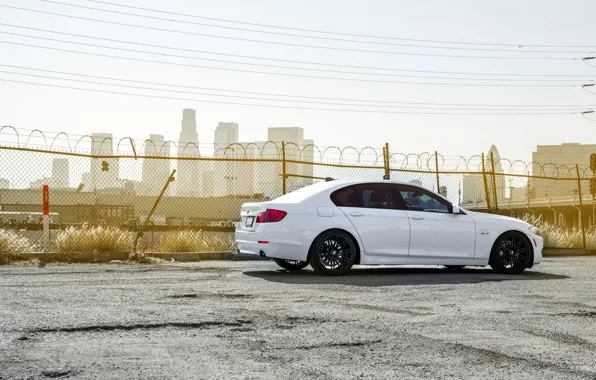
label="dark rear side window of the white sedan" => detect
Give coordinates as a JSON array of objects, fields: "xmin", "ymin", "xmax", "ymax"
[{"xmin": 331, "ymin": 183, "xmax": 398, "ymax": 210}]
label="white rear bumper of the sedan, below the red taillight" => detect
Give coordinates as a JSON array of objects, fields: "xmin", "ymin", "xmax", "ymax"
[{"xmin": 236, "ymin": 223, "xmax": 312, "ymax": 261}]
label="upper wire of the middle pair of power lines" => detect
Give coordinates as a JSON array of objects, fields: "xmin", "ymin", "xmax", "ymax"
[{"xmin": 0, "ymin": 22, "xmax": 589, "ymax": 79}]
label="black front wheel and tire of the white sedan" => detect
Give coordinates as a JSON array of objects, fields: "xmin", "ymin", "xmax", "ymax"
[{"xmin": 488, "ymin": 231, "xmax": 532, "ymax": 274}]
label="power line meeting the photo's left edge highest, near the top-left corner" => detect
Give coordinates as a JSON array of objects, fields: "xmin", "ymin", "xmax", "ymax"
[{"xmin": 0, "ymin": 5, "xmax": 583, "ymax": 60}]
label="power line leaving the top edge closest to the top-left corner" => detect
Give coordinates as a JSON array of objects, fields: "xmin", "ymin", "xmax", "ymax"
[{"xmin": 40, "ymin": 0, "xmax": 592, "ymax": 54}]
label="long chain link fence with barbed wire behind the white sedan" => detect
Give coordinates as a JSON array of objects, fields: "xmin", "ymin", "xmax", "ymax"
[{"xmin": 0, "ymin": 127, "xmax": 596, "ymax": 252}]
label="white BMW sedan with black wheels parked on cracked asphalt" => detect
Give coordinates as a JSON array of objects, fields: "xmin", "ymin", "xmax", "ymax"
[{"xmin": 236, "ymin": 180, "xmax": 543, "ymax": 275}]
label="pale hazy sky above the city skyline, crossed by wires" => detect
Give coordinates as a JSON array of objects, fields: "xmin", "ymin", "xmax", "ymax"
[{"xmin": 0, "ymin": 0, "xmax": 596, "ymax": 160}]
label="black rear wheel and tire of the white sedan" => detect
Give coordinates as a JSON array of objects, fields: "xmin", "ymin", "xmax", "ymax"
[{"xmin": 310, "ymin": 230, "xmax": 358, "ymax": 276}]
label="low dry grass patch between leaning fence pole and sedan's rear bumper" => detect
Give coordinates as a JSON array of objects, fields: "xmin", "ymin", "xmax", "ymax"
[{"xmin": 145, "ymin": 231, "xmax": 235, "ymax": 252}]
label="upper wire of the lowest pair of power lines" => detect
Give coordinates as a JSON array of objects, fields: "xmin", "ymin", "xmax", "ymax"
[{"xmin": 0, "ymin": 64, "xmax": 595, "ymax": 109}]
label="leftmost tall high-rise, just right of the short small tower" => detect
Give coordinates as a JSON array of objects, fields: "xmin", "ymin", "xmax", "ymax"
[{"xmin": 89, "ymin": 133, "xmax": 120, "ymax": 190}]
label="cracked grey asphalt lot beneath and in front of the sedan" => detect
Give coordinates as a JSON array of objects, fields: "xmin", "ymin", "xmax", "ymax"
[{"xmin": 0, "ymin": 258, "xmax": 596, "ymax": 380}]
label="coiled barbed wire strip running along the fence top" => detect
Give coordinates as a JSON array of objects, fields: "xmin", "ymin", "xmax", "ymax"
[{"xmin": 0, "ymin": 125, "xmax": 592, "ymax": 178}]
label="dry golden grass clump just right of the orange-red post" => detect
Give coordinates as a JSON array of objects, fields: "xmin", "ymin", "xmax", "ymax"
[{"xmin": 55, "ymin": 226, "xmax": 134, "ymax": 261}]
